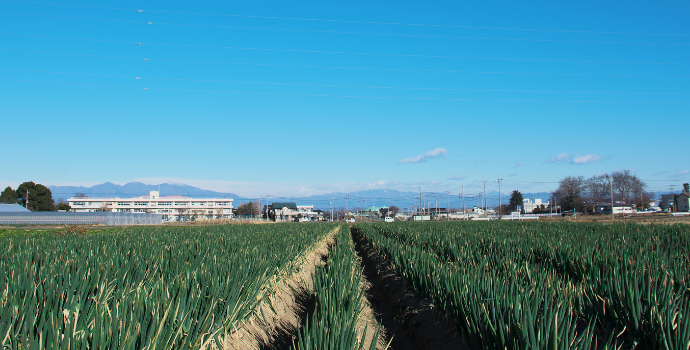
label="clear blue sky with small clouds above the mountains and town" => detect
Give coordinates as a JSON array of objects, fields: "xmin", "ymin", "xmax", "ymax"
[{"xmin": 0, "ymin": 0, "xmax": 690, "ymax": 196}]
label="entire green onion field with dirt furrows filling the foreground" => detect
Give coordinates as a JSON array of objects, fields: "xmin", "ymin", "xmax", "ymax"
[{"xmin": 0, "ymin": 221, "xmax": 690, "ymax": 350}]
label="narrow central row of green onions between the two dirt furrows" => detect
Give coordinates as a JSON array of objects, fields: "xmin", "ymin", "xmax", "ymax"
[{"xmin": 293, "ymin": 226, "xmax": 380, "ymax": 350}]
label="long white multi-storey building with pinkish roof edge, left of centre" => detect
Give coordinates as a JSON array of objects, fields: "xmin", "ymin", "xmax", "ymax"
[{"xmin": 68, "ymin": 191, "xmax": 233, "ymax": 221}]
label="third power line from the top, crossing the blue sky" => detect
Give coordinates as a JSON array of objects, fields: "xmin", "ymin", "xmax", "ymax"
[{"xmin": 0, "ymin": 33, "xmax": 690, "ymax": 65}]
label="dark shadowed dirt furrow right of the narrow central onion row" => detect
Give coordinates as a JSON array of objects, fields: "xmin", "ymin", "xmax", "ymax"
[{"xmin": 352, "ymin": 230, "xmax": 469, "ymax": 350}]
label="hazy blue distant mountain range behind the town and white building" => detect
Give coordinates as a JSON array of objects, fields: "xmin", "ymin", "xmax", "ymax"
[{"xmin": 49, "ymin": 182, "xmax": 549, "ymax": 210}]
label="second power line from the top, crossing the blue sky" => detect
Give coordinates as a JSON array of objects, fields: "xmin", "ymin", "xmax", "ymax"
[{"xmin": 0, "ymin": 12, "xmax": 690, "ymax": 46}]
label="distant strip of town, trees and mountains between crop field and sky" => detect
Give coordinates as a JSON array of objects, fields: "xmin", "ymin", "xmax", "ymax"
[{"xmin": 0, "ymin": 170, "xmax": 690, "ymax": 224}]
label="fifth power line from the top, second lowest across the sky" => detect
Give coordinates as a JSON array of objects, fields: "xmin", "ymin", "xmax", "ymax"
[{"xmin": 0, "ymin": 68, "xmax": 690, "ymax": 95}]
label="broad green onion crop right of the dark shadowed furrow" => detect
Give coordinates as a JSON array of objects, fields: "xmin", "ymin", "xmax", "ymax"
[{"xmin": 353, "ymin": 222, "xmax": 690, "ymax": 349}]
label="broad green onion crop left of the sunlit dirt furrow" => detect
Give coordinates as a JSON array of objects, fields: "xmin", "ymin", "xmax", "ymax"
[{"xmin": 0, "ymin": 224, "xmax": 335, "ymax": 349}]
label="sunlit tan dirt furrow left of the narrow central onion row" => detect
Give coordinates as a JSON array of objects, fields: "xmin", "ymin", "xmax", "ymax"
[{"xmin": 220, "ymin": 226, "xmax": 340, "ymax": 350}]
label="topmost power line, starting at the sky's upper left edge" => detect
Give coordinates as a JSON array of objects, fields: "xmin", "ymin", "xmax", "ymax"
[{"xmin": 3, "ymin": 0, "xmax": 690, "ymax": 36}]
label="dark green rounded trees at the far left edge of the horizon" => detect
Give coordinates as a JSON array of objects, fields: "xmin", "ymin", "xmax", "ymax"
[{"xmin": 0, "ymin": 181, "xmax": 72, "ymax": 211}]
